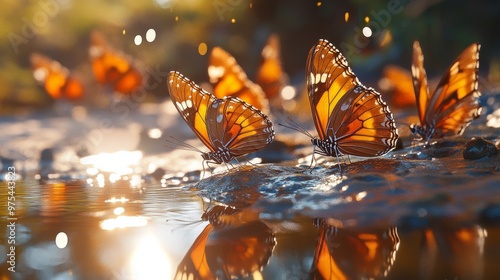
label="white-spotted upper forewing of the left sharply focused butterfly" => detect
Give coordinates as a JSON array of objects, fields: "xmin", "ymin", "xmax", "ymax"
[{"xmin": 167, "ymin": 71, "xmax": 217, "ymax": 152}]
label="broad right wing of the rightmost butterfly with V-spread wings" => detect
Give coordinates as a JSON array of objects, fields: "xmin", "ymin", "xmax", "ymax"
[{"xmin": 423, "ymin": 43, "xmax": 481, "ymax": 135}]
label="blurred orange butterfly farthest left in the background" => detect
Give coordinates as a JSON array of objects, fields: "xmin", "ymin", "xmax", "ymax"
[{"xmin": 31, "ymin": 53, "xmax": 84, "ymax": 100}]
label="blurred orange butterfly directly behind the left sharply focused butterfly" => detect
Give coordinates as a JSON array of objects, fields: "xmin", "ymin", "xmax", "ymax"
[{"xmin": 208, "ymin": 47, "xmax": 269, "ymax": 113}]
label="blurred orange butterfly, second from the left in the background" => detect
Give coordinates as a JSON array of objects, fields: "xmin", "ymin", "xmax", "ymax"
[{"xmin": 89, "ymin": 32, "xmax": 144, "ymax": 95}]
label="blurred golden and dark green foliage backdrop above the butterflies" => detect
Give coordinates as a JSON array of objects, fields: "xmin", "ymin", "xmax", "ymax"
[{"xmin": 0, "ymin": 0, "xmax": 500, "ymax": 115}]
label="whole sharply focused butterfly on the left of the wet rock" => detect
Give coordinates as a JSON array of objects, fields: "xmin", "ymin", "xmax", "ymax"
[{"xmin": 167, "ymin": 71, "xmax": 274, "ymax": 164}]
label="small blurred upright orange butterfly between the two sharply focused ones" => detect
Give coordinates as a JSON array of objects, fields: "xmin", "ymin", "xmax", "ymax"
[{"xmin": 255, "ymin": 34, "xmax": 286, "ymax": 100}]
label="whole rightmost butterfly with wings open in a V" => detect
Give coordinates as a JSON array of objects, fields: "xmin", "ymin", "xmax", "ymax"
[{"xmin": 410, "ymin": 41, "xmax": 481, "ymax": 145}]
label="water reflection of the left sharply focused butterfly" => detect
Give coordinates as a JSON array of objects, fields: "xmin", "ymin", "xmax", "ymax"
[{"xmin": 174, "ymin": 206, "xmax": 276, "ymax": 279}]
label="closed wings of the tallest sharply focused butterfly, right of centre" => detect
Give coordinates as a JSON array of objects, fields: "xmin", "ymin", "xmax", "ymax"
[{"xmin": 306, "ymin": 40, "xmax": 398, "ymax": 156}]
